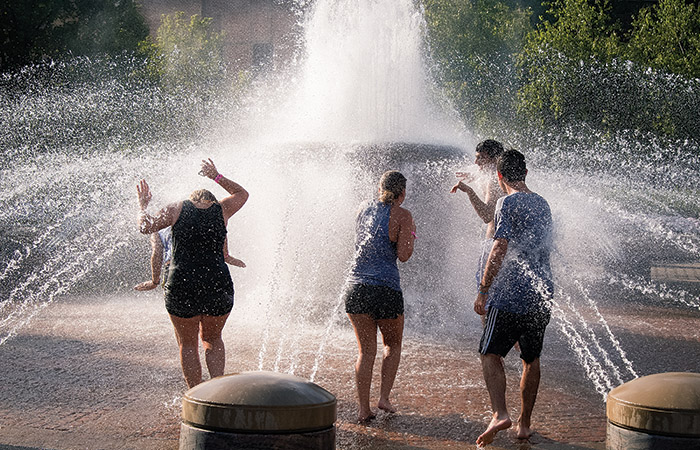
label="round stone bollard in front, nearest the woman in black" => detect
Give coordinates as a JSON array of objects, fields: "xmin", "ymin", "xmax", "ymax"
[{"xmin": 180, "ymin": 372, "xmax": 336, "ymax": 450}]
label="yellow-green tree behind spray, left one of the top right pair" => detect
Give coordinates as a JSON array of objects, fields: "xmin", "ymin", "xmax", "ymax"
[{"xmin": 518, "ymin": 0, "xmax": 620, "ymax": 125}]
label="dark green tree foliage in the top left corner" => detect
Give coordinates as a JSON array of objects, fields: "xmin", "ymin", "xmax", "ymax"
[{"xmin": 0, "ymin": 0, "xmax": 148, "ymax": 72}]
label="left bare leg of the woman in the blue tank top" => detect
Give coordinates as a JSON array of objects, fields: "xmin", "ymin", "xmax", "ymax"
[{"xmin": 348, "ymin": 314, "xmax": 377, "ymax": 423}]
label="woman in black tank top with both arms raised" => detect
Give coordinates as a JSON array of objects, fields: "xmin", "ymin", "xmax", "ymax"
[{"xmin": 136, "ymin": 159, "xmax": 248, "ymax": 388}]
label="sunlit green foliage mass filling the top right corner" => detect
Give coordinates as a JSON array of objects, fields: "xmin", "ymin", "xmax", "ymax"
[{"xmin": 518, "ymin": 0, "xmax": 700, "ymax": 137}]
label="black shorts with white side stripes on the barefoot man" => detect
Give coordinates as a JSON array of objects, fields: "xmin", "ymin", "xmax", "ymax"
[{"xmin": 479, "ymin": 307, "xmax": 550, "ymax": 363}]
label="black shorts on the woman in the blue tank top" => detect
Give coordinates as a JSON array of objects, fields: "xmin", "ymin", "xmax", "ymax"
[{"xmin": 345, "ymin": 284, "xmax": 403, "ymax": 320}]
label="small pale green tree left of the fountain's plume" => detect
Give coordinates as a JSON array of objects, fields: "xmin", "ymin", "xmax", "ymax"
[{"xmin": 140, "ymin": 11, "xmax": 226, "ymax": 92}]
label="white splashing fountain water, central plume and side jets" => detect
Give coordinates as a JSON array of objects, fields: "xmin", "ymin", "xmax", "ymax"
[{"xmin": 0, "ymin": 0, "xmax": 700, "ymax": 397}]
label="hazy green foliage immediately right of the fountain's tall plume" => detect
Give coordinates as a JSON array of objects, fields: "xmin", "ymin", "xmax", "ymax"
[{"xmin": 424, "ymin": 0, "xmax": 531, "ymax": 133}]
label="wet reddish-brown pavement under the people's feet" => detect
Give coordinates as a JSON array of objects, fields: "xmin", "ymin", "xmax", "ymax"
[{"xmin": 0, "ymin": 293, "xmax": 700, "ymax": 450}]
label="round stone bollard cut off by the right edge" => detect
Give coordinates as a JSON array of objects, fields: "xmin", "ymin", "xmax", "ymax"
[{"xmin": 606, "ymin": 372, "xmax": 700, "ymax": 450}]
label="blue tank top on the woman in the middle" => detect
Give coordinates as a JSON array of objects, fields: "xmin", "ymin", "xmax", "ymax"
[{"xmin": 348, "ymin": 200, "xmax": 401, "ymax": 291}]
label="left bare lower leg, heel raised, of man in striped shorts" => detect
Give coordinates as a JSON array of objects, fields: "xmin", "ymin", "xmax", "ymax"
[{"xmin": 476, "ymin": 353, "xmax": 513, "ymax": 447}]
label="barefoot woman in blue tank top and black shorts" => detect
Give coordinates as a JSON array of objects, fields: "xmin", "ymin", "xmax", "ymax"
[{"xmin": 345, "ymin": 171, "xmax": 416, "ymax": 423}]
